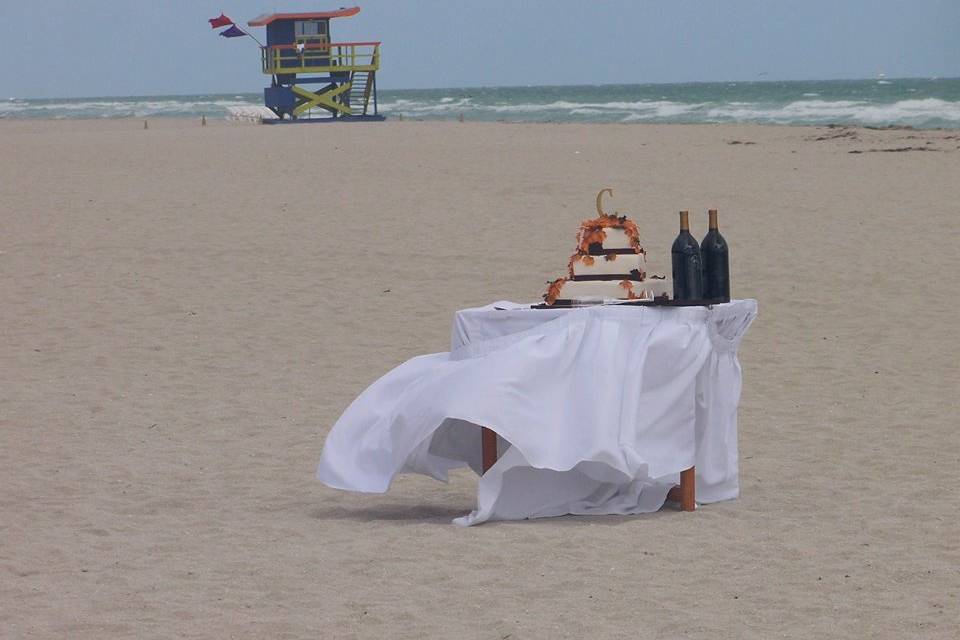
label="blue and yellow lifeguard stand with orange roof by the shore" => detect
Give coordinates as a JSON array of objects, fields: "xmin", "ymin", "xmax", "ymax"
[{"xmin": 247, "ymin": 7, "xmax": 383, "ymax": 122}]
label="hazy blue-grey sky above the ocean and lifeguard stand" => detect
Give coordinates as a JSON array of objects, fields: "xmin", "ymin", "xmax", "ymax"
[{"xmin": 0, "ymin": 0, "xmax": 960, "ymax": 98}]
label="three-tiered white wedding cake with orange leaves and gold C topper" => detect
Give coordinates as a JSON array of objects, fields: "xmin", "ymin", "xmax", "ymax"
[{"xmin": 543, "ymin": 189, "xmax": 662, "ymax": 304}]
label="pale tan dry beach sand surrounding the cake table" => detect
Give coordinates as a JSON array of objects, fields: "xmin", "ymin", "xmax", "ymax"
[{"xmin": 0, "ymin": 120, "xmax": 960, "ymax": 639}]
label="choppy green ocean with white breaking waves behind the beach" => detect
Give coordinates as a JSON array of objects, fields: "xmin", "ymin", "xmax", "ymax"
[{"xmin": 0, "ymin": 78, "xmax": 960, "ymax": 128}]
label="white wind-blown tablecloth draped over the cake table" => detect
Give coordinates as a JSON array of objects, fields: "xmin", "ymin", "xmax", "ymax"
[{"xmin": 317, "ymin": 300, "xmax": 757, "ymax": 525}]
